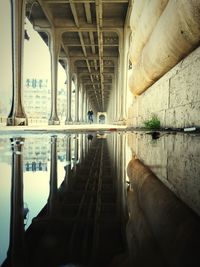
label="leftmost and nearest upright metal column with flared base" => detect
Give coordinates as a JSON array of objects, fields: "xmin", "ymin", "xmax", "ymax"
[{"xmin": 7, "ymin": 0, "xmax": 28, "ymax": 125}]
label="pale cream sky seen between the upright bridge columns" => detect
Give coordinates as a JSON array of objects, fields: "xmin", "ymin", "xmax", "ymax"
[{"xmin": 0, "ymin": 0, "xmax": 66, "ymax": 114}]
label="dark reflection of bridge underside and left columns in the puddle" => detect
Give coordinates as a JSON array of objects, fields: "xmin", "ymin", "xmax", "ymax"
[{"xmin": 3, "ymin": 136, "xmax": 125, "ymax": 267}]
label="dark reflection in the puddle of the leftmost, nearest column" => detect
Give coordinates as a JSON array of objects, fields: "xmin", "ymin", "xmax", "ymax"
[{"xmin": 8, "ymin": 138, "xmax": 25, "ymax": 267}]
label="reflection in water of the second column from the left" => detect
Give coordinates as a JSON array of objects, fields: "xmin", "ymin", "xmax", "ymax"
[{"xmin": 48, "ymin": 136, "xmax": 57, "ymax": 216}]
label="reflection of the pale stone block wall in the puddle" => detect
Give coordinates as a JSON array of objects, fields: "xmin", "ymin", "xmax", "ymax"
[{"xmin": 129, "ymin": 134, "xmax": 200, "ymax": 217}]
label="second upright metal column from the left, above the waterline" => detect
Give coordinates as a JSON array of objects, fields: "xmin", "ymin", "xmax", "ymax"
[{"xmin": 49, "ymin": 30, "xmax": 60, "ymax": 125}]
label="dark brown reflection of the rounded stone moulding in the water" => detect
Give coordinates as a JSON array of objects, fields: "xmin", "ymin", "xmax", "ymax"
[{"xmin": 127, "ymin": 159, "xmax": 200, "ymax": 267}]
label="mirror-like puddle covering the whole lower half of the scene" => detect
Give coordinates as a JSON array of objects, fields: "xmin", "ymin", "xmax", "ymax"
[{"xmin": 0, "ymin": 132, "xmax": 200, "ymax": 267}]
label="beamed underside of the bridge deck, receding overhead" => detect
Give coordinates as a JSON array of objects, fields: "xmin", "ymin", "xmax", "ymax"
[{"xmin": 26, "ymin": 0, "xmax": 129, "ymax": 112}]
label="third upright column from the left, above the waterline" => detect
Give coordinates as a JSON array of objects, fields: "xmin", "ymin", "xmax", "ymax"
[{"xmin": 65, "ymin": 59, "xmax": 72, "ymax": 124}]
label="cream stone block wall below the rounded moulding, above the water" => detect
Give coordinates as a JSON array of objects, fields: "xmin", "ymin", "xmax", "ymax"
[{"xmin": 127, "ymin": 47, "xmax": 200, "ymax": 127}]
